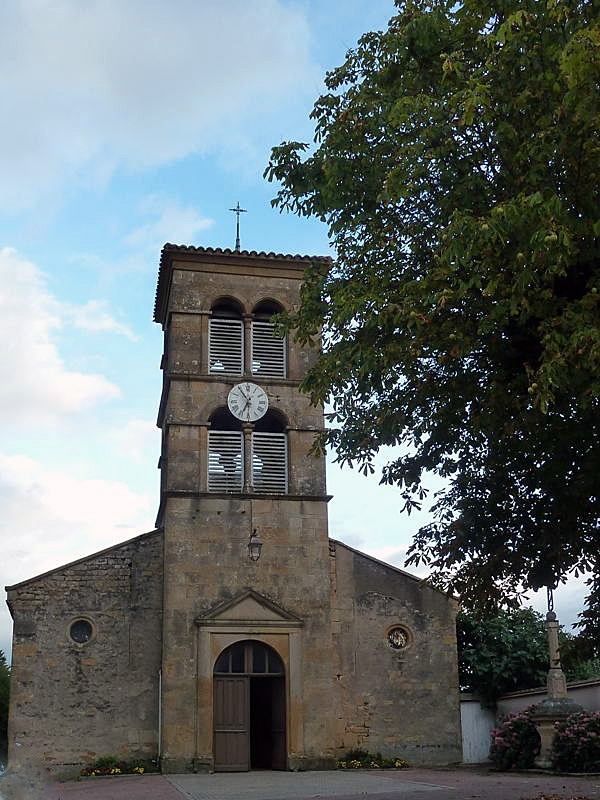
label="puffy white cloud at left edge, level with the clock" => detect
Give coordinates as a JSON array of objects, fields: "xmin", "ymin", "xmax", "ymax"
[{"xmin": 0, "ymin": 248, "xmax": 119, "ymax": 424}]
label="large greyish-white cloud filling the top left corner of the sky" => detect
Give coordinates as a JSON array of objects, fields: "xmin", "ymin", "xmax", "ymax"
[{"xmin": 0, "ymin": 0, "xmax": 316, "ymax": 210}]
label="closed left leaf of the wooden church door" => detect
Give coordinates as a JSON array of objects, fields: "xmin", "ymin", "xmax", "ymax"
[{"xmin": 213, "ymin": 675, "xmax": 250, "ymax": 772}]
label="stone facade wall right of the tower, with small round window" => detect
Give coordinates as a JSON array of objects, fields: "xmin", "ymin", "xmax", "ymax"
[{"xmin": 331, "ymin": 542, "xmax": 461, "ymax": 765}]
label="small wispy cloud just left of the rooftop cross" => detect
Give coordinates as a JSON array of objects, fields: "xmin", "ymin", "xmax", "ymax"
[{"xmin": 125, "ymin": 195, "xmax": 214, "ymax": 256}]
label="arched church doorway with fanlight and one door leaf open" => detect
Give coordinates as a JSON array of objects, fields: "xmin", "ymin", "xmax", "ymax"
[{"xmin": 213, "ymin": 639, "xmax": 286, "ymax": 772}]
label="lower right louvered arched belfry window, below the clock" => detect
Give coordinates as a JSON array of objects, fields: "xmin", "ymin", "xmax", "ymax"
[{"xmin": 252, "ymin": 409, "xmax": 288, "ymax": 494}]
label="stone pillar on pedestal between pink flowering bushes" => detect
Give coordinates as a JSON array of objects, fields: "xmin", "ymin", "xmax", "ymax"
[{"xmin": 533, "ymin": 611, "xmax": 581, "ymax": 769}]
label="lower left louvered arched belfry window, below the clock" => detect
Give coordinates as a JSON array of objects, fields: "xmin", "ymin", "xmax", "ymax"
[{"xmin": 208, "ymin": 408, "xmax": 244, "ymax": 492}]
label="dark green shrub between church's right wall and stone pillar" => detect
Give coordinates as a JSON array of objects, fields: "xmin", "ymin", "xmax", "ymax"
[{"xmin": 456, "ymin": 608, "xmax": 548, "ymax": 703}]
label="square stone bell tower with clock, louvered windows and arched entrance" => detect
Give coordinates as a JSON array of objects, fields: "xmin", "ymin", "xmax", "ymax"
[{"xmin": 154, "ymin": 244, "xmax": 335, "ymax": 772}]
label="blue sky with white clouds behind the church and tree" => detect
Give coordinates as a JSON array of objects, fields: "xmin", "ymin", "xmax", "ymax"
[{"xmin": 0, "ymin": 0, "xmax": 582, "ymax": 656}]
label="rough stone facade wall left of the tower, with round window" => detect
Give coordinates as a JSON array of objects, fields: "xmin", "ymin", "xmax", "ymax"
[{"xmin": 8, "ymin": 531, "xmax": 163, "ymax": 770}]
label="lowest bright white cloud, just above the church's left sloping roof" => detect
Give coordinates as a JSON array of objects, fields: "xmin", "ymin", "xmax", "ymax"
[{"xmin": 0, "ymin": 454, "xmax": 155, "ymax": 664}]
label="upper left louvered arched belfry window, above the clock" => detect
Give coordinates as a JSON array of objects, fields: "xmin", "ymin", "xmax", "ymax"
[{"xmin": 208, "ymin": 298, "xmax": 244, "ymax": 375}]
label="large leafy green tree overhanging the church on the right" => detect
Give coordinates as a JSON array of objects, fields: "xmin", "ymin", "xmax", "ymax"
[{"xmin": 265, "ymin": 0, "xmax": 600, "ymax": 634}]
